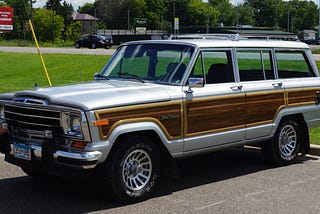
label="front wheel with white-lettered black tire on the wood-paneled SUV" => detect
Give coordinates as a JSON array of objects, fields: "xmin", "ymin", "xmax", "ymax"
[{"xmin": 107, "ymin": 135, "xmax": 161, "ymax": 204}]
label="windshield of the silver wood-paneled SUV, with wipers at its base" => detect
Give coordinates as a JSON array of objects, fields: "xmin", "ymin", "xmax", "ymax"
[{"xmin": 100, "ymin": 44, "xmax": 194, "ymax": 84}]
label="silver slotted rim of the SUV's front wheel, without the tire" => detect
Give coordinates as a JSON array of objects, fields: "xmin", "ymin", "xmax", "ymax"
[{"xmin": 122, "ymin": 149, "xmax": 152, "ymax": 191}]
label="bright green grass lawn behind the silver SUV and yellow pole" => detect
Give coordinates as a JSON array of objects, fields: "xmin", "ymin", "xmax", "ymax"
[{"xmin": 0, "ymin": 52, "xmax": 320, "ymax": 145}]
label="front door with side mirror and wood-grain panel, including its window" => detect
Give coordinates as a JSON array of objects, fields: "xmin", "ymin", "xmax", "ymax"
[{"xmin": 184, "ymin": 49, "xmax": 245, "ymax": 152}]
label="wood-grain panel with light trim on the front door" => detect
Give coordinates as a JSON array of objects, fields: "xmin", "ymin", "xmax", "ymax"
[{"xmin": 184, "ymin": 93, "xmax": 245, "ymax": 137}]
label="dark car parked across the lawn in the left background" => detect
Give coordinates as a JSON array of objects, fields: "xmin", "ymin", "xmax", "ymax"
[{"xmin": 75, "ymin": 35, "xmax": 113, "ymax": 49}]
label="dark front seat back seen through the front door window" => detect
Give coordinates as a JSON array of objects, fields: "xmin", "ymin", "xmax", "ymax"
[{"xmin": 207, "ymin": 63, "xmax": 234, "ymax": 83}]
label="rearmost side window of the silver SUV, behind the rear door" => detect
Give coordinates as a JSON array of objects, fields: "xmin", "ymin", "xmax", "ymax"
[{"xmin": 276, "ymin": 51, "xmax": 314, "ymax": 78}]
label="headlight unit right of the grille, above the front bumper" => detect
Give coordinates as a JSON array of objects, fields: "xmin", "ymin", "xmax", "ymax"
[{"xmin": 62, "ymin": 112, "xmax": 86, "ymax": 138}]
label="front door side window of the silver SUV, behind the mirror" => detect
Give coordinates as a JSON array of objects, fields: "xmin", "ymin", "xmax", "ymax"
[{"xmin": 192, "ymin": 51, "xmax": 234, "ymax": 84}]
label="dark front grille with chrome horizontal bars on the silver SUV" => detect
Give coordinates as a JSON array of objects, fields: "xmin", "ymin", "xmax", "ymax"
[{"xmin": 4, "ymin": 104, "xmax": 62, "ymax": 139}]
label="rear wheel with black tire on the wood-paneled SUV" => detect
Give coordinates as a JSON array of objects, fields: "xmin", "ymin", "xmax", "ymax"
[{"xmin": 262, "ymin": 118, "xmax": 303, "ymax": 166}]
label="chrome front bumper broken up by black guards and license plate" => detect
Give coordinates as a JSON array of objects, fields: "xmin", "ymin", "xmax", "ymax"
[{"xmin": 10, "ymin": 144, "xmax": 102, "ymax": 169}]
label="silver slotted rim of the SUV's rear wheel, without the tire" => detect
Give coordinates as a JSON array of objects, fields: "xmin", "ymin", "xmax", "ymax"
[{"xmin": 279, "ymin": 124, "xmax": 298, "ymax": 158}]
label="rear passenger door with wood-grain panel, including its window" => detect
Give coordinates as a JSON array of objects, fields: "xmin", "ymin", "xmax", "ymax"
[{"xmin": 236, "ymin": 49, "xmax": 285, "ymax": 139}]
